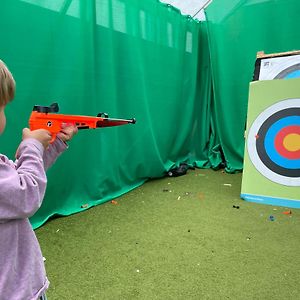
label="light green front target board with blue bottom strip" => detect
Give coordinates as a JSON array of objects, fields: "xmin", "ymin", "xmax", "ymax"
[{"xmin": 241, "ymin": 78, "xmax": 300, "ymax": 208}]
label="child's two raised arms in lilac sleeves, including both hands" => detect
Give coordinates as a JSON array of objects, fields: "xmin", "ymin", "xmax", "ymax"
[{"xmin": 0, "ymin": 126, "xmax": 77, "ymax": 223}]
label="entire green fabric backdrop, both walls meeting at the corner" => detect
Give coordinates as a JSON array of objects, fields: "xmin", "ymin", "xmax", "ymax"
[{"xmin": 0, "ymin": 0, "xmax": 300, "ymax": 228}]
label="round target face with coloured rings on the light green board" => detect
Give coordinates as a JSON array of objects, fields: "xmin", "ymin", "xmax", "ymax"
[{"xmin": 247, "ymin": 99, "xmax": 300, "ymax": 186}]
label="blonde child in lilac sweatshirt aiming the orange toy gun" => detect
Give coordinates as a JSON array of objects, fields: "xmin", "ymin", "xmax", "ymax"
[{"xmin": 0, "ymin": 60, "xmax": 77, "ymax": 300}]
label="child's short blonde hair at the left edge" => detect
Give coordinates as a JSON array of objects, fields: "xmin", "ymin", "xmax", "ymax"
[{"xmin": 0, "ymin": 59, "xmax": 16, "ymax": 107}]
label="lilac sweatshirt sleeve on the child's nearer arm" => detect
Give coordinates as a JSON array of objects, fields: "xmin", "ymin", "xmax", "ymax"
[{"xmin": 0, "ymin": 138, "xmax": 47, "ymax": 222}]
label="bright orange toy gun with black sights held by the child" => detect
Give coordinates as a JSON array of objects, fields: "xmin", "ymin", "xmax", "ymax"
[{"xmin": 29, "ymin": 103, "xmax": 136, "ymax": 143}]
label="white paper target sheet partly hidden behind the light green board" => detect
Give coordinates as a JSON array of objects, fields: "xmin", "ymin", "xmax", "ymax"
[{"xmin": 259, "ymin": 55, "xmax": 300, "ymax": 80}]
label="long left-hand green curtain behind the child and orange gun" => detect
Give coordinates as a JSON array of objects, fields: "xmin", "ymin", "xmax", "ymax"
[{"xmin": 0, "ymin": 0, "xmax": 215, "ymax": 228}]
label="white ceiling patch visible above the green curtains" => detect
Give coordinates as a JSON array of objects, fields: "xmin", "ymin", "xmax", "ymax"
[{"xmin": 160, "ymin": 0, "xmax": 212, "ymax": 20}]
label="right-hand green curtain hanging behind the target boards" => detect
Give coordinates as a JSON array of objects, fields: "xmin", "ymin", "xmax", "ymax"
[{"xmin": 206, "ymin": 0, "xmax": 300, "ymax": 172}]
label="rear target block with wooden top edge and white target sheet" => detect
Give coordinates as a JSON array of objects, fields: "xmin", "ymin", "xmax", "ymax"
[{"xmin": 253, "ymin": 51, "xmax": 300, "ymax": 80}]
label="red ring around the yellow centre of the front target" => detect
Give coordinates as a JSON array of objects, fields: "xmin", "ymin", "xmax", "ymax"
[{"xmin": 274, "ymin": 125, "xmax": 300, "ymax": 159}]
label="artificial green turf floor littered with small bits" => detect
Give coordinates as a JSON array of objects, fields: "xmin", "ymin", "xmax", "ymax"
[{"xmin": 36, "ymin": 169, "xmax": 300, "ymax": 300}]
